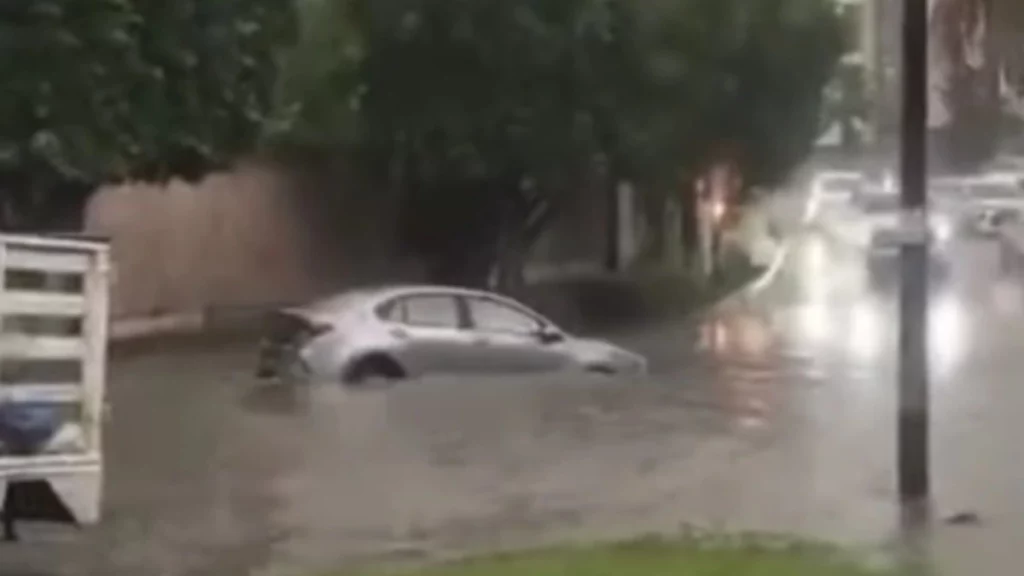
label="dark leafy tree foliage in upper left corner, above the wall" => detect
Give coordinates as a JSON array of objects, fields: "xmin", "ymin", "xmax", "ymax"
[{"xmin": 0, "ymin": 0, "xmax": 294, "ymax": 230}]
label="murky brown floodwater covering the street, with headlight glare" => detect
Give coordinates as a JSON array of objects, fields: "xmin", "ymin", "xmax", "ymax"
[{"xmin": 0, "ymin": 190, "xmax": 1024, "ymax": 576}]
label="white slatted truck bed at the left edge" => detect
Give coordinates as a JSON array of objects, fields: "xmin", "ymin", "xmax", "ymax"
[{"xmin": 0, "ymin": 235, "xmax": 110, "ymax": 525}]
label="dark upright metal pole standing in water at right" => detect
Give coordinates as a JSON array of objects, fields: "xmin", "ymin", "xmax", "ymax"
[{"xmin": 897, "ymin": 0, "xmax": 931, "ymax": 502}]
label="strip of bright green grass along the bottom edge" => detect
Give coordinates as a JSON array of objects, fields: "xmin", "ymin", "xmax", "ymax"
[{"xmin": 330, "ymin": 540, "xmax": 899, "ymax": 576}]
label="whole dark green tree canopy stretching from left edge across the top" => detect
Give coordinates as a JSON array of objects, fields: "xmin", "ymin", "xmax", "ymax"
[{"xmin": 0, "ymin": 0, "xmax": 842, "ymax": 278}]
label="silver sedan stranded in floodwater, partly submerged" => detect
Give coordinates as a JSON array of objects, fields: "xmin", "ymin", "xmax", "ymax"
[{"xmin": 257, "ymin": 286, "xmax": 647, "ymax": 384}]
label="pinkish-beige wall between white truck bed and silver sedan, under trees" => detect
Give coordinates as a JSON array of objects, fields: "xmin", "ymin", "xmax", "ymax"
[{"xmin": 85, "ymin": 166, "xmax": 318, "ymax": 319}]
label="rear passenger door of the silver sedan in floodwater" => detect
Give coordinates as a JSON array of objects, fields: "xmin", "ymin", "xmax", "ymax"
[{"xmin": 388, "ymin": 293, "xmax": 473, "ymax": 376}]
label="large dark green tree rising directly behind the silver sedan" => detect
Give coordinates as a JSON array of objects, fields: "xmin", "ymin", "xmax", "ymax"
[{"xmin": 284, "ymin": 0, "xmax": 841, "ymax": 284}]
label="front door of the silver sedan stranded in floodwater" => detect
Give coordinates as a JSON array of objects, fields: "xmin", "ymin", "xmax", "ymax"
[{"xmin": 466, "ymin": 296, "xmax": 566, "ymax": 373}]
